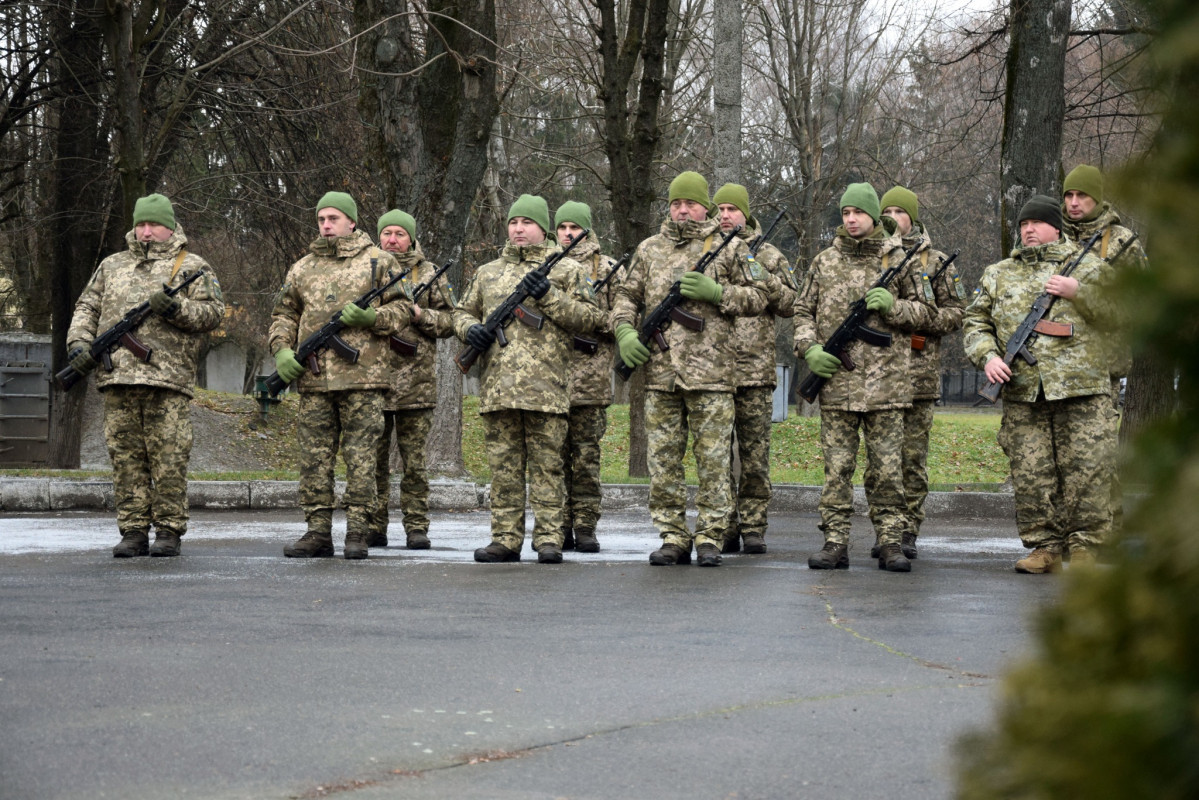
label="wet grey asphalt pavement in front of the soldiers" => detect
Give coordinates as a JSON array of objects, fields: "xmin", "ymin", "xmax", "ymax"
[{"xmin": 0, "ymin": 511, "xmax": 1068, "ymax": 800}]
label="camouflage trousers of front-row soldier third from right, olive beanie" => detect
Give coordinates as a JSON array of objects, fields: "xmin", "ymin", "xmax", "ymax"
[{"xmin": 645, "ymin": 389, "xmax": 734, "ymax": 549}]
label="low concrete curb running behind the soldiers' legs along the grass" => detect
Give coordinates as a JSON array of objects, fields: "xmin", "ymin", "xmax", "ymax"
[{"xmin": 0, "ymin": 477, "xmax": 1016, "ymax": 519}]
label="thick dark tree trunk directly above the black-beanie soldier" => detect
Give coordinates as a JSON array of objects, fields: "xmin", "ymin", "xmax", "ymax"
[{"xmin": 1000, "ymin": 0, "xmax": 1071, "ymax": 253}]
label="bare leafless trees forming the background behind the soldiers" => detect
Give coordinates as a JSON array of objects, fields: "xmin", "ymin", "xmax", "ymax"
[{"xmin": 0, "ymin": 0, "xmax": 1167, "ymax": 474}]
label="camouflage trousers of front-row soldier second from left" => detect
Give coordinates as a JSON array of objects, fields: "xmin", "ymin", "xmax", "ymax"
[{"xmin": 299, "ymin": 390, "xmax": 384, "ymax": 534}]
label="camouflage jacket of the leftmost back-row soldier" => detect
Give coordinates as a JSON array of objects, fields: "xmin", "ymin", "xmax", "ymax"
[{"xmin": 384, "ymin": 243, "xmax": 454, "ymax": 411}]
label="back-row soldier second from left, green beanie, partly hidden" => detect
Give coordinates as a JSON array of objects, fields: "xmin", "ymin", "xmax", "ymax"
[{"xmin": 554, "ymin": 201, "xmax": 620, "ymax": 553}]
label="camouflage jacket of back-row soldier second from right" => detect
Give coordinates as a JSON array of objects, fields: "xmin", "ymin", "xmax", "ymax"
[{"xmin": 903, "ymin": 222, "xmax": 966, "ymax": 401}]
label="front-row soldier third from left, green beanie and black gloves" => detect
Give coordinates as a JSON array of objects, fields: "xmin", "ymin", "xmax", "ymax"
[{"xmin": 453, "ymin": 194, "xmax": 603, "ymax": 564}]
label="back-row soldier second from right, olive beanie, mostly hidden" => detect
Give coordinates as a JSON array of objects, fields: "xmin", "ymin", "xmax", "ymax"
[{"xmin": 870, "ymin": 186, "xmax": 966, "ymax": 559}]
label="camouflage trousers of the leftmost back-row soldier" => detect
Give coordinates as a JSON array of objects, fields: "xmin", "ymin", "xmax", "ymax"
[{"xmin": 370, "ymin": 408, "xmax": 433, "ymax": 534}]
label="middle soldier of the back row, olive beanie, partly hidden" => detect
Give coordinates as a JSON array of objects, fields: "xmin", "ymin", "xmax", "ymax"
[{"xmin": 712, "ymin": 184, "xmax": 796, "ymax": 553}]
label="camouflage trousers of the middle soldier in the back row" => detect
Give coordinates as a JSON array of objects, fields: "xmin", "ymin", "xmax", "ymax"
[{"xmin": 730, "ymin": 386, "xmax": 775, "ymax": 536}]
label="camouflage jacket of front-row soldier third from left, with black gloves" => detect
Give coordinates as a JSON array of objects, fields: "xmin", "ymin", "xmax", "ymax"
[{"xmin": 453, "ymin": 240, "xmax": 603, "ymax": 414}]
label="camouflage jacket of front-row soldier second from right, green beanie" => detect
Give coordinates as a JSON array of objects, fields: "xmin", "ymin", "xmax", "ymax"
[{"xmin": 795, "ymin": 217, "xmax": 933, "ymax": 411}]
